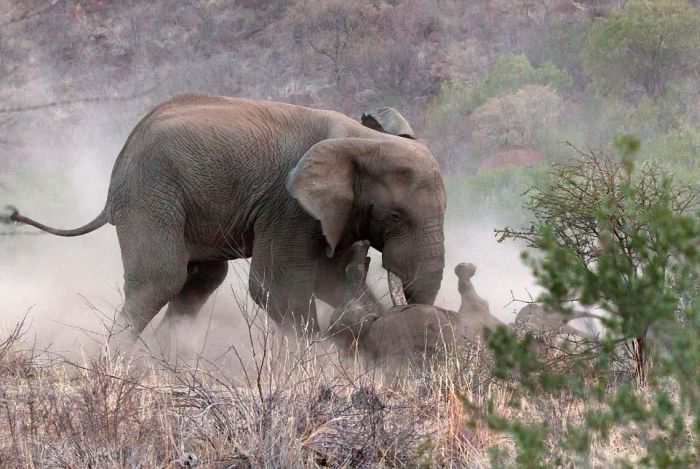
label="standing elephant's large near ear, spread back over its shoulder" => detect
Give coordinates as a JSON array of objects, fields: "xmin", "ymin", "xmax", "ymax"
[{"xmin": 287, "ymin": 138, "xmax": 379, "ymax": 257}]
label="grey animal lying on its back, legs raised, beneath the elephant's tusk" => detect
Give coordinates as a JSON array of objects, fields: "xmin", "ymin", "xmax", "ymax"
[{"xmin": 327, "ymin": 242, "xmax": 502, "ymax": 365}]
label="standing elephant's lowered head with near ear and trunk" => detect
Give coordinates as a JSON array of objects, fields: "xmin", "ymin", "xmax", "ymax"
[{"xmin": 287, "ymin": 136, "xmax": 446, "ymax": 304}]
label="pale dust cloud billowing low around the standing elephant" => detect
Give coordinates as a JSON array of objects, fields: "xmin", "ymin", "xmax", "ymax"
[{"xmin": 0, "ymin": 119, "xmax": 532, "ymax": 357}]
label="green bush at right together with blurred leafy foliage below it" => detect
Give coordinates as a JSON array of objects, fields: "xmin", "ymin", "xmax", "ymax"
[{"xmin": 487, "ymin": 138, "xmax": 700, "ymax": 467}]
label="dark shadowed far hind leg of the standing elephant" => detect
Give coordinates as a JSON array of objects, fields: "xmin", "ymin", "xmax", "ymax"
[{"xmin": 156, "ymin": 261, "xmax": 228, "ymax": 336}]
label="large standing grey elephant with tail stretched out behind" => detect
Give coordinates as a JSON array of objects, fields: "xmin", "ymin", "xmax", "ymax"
[{"xmin": 11, "ymin": 95, "xmax": 446, "ymax": 339}]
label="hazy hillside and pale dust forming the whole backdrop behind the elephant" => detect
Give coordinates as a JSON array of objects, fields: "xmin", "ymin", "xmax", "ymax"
[{"xmin": 0, "ymin": 0, "xmax": 700, "ymax": 356}]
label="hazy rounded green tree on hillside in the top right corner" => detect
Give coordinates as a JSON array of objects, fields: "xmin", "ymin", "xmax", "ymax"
[{"xmin": 585, "ymin": 0, "xmax": 700, "ymax": 101}]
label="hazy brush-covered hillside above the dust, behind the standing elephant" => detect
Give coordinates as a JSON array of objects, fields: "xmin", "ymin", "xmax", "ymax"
[{"xmin": 0, "ymin": 0, "xmax": 700, "ymax": 220}]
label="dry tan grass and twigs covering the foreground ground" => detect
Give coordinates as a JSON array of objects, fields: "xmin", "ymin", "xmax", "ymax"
[{"xmin": 0, "ymin": 308, "xmax": 652, "ymax": 468}]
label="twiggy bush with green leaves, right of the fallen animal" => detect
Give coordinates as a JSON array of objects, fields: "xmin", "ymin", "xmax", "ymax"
[{"xmin": 497, "ymin": 137, "xmax": 700, "ymax": 380}]
